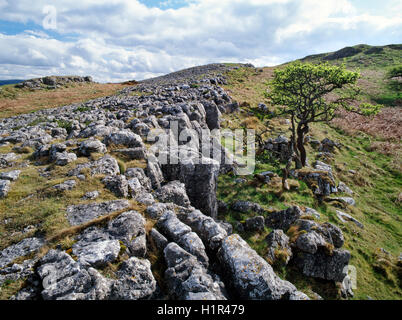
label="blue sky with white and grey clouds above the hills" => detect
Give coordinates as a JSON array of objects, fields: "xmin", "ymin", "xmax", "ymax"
[{"xmin": 0, "ymin": 0, "xmax": 402, "ymax": 82}]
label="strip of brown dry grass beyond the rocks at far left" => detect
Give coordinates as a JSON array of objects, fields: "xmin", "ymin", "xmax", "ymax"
[{"xmin": 0, "ymin": 83, "xmax": 128, "ymax": 118}]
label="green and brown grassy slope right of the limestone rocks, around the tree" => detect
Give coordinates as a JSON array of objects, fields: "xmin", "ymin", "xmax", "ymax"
[{"xmin": 218, "ymin": 46, "xmax": 402, "ymax": 299}]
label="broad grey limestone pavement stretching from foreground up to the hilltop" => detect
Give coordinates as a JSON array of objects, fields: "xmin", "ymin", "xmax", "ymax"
[{"xmin": 0, "ymin": 65, "xmax": 326, "ymax": 300}]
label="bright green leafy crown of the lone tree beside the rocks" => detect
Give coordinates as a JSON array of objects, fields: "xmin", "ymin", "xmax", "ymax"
[{"xmin": 267, "ymin": 62, "xmax": 379, "ymax": 123}]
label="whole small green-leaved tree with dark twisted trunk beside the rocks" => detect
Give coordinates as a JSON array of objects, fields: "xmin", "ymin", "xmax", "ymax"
[{"xmin": 268, "ymin": 62, "xmax": 380, "ymax": 186}]
